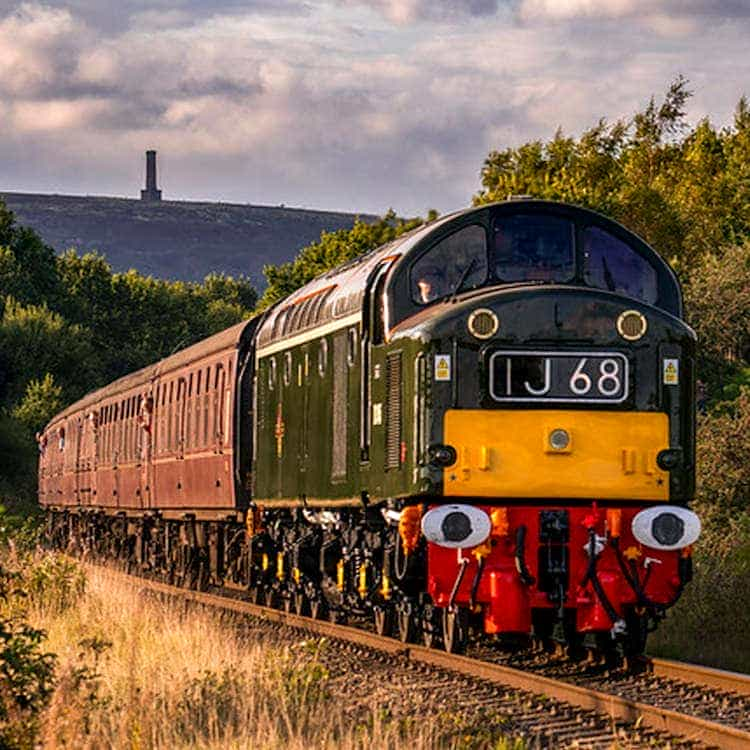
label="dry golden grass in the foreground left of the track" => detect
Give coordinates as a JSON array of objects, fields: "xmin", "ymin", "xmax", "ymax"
[{"xmin": 16, "ymin": 569, "xmax": 452, "ymax": 750}]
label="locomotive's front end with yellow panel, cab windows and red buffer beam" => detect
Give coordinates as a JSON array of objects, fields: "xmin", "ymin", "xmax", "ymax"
[{"xmin": 390, "ymin": 201, "xmax": 700, "ymax": 654}]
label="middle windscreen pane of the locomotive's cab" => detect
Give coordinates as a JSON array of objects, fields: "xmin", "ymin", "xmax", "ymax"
[{"xmin": 492, "ymin": 214, "xmax": 575, "ymax": 282}]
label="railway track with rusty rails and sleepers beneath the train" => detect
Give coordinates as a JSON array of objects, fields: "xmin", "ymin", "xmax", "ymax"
[{"xmin": 94, "ymin": 568, "xmax": 750, "ymax": 750}]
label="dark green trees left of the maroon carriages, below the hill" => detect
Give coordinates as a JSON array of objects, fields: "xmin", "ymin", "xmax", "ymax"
[{"xmin": 0, "ymin": 214, "xmax": 258, "ymax": 497}]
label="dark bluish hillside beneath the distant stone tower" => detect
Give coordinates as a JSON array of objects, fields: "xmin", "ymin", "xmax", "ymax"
[{"xmin": 0, "ymin": 193, "xmax": 374, "ymax": 287}]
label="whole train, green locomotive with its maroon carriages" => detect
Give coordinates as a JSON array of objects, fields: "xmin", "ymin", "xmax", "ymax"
[{"xmin": 39, "ymin": 198, "xmax": 700, "ymax": 657}]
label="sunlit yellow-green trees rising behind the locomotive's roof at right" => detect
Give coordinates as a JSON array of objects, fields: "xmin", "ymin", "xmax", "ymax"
[{"xmin": 474, "ymin": 77, "xmax": 750, "ymax": 278}]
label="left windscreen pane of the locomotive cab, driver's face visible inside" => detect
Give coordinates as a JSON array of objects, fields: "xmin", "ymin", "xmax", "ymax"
[{"xmin": 410, "ymin": 224, "xmax": 487, "ymax": 305}]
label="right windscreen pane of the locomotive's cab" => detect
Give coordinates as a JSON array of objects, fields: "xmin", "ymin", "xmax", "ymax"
[{"xmin": 583, "ymin": 227, "xmax": 659, "ymax": 305}]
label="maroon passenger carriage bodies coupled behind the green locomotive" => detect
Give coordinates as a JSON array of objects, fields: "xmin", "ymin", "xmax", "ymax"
[{"xmin": 39, "ymin": 321, "xmax": 255, "ymax": 516}]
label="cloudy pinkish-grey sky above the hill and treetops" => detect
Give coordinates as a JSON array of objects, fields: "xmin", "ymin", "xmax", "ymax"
[{"xmin": 0, "ymin": 0, "xmax": 750, "ymax": 215}]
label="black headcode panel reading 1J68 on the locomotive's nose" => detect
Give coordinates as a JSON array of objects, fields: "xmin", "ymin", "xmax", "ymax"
[{"xmin": 490, "ymin": 351, "xmax": 628, "ymax": 404}]
